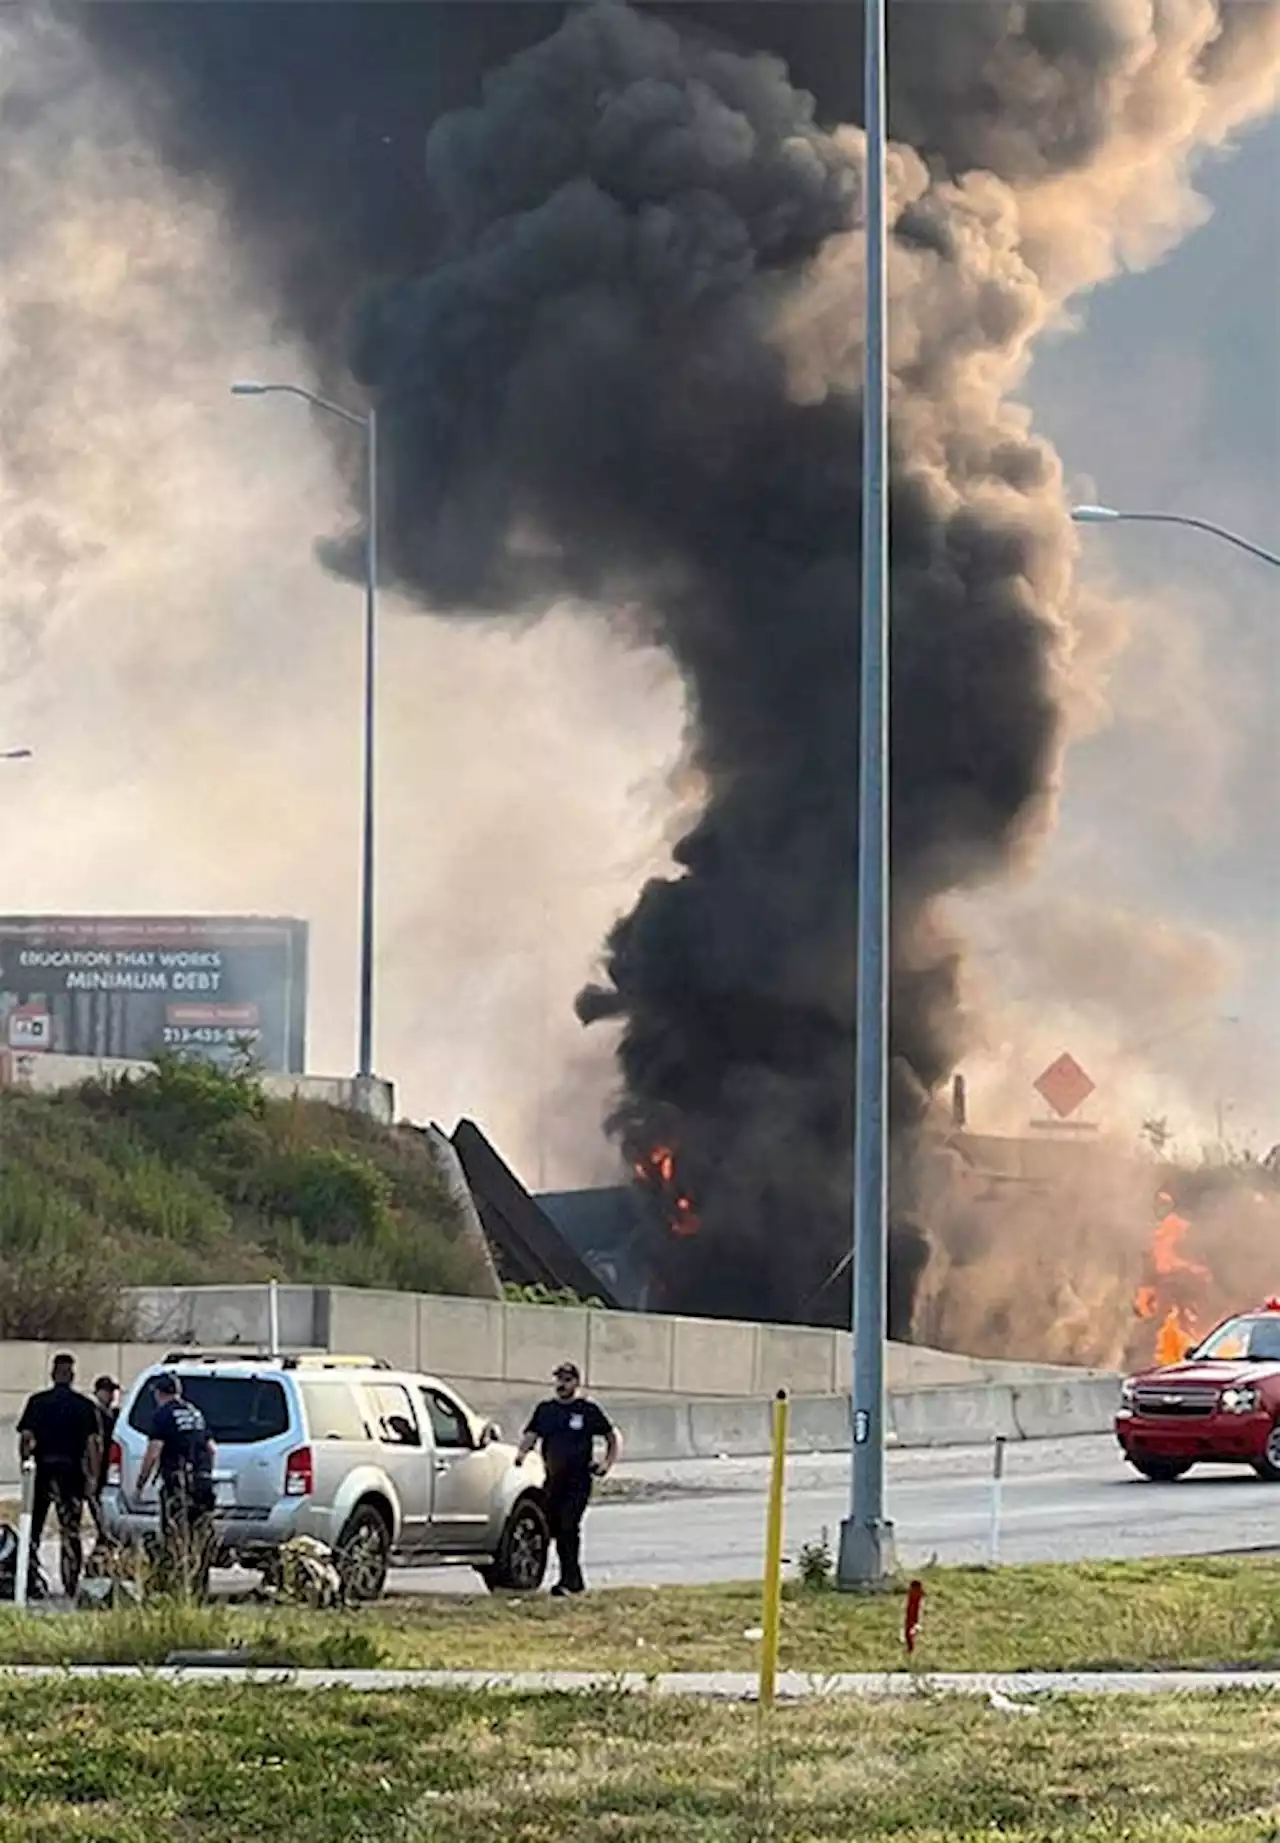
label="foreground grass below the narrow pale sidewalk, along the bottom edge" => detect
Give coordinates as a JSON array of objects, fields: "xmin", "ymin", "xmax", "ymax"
[{"xmin": 0, "ymin": 1681, "xmax": 1280, "ymax": 1843}]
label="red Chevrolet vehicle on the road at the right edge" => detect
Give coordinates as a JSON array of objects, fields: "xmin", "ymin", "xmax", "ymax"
[{"xmin": 1116, "ymin": 1299, "xmax": 1280, "ymax": 1482}]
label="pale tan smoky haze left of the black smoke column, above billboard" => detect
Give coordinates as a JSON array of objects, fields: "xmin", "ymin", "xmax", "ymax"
[{"xmin": 0, "ymin": 10, "xmax": 683, "ymax": 1181}]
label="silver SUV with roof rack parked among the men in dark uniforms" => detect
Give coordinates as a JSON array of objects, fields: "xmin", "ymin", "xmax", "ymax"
[{"xmin": 103, "ymin": 1351, "xmax": 549, "ymax": 1600}]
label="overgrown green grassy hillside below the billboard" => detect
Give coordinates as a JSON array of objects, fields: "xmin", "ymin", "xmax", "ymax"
[{"xmin": 0, "ymin": 1062, "xmax": 497, "ymax": 1340}]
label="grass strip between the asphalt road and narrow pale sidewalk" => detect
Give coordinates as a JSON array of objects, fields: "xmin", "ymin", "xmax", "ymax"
[{"xmin": 0, "ymin": 1557, "xmax": 1280, "ymax": 1672}]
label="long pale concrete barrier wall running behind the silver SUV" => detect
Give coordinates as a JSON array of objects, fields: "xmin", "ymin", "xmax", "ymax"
[{"xmin": 0, "ymin": 1286, "xmax": 1118, "ymax": 1484}]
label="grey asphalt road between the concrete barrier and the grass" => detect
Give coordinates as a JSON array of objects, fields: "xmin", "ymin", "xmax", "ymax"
[{"xmin": 392, "ymin": 1436, "xmax": 1280, "ymax": 1592}]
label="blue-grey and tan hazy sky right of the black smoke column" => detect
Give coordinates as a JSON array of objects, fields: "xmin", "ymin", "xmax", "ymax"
[{"xmin": 976, "ymin": 120, "xmax": 1280, "ymax": 1150}]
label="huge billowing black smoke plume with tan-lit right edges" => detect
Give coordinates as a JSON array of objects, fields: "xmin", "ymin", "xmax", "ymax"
[{"xmin": 69, "ymin": 0, "xmax": 1276, "ymax": 1334}]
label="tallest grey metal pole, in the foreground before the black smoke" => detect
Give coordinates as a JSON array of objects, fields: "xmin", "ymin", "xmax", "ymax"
[{"xmin": 836, "ymin": 0, "xmax": 897, "ymax": 1589}]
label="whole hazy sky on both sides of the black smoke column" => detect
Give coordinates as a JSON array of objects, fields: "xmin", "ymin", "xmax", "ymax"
[{"xmin": 0, "ymin": 10, "xmax": 1280, "ymax": 1185}]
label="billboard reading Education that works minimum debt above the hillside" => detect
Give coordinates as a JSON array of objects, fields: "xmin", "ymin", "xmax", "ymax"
[{"xmin": 0, "ymin": 916, "xmax": 308, "ymax": 1074}]
